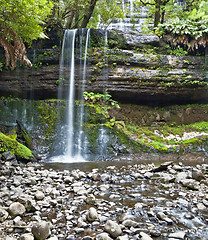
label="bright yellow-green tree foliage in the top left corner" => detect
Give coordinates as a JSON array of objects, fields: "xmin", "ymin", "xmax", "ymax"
[{"xmin": 0, "ymin": 0, "xmax": 53, "ymax": 44}]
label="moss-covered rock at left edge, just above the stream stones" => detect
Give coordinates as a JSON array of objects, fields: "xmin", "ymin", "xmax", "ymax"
[{"xmin": 0, "ymin": 132, "xmax": 34, "ymax": 160}]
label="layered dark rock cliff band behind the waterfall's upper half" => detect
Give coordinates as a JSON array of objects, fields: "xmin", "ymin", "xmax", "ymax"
[{"xmin": 0, "ymin": 30, "xmax": 208, "ymax": 104}]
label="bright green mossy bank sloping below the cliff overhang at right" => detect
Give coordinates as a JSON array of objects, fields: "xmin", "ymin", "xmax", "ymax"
[{"xmin": 115, "ymin": 122, "xmax": 208, "ymax": 151}]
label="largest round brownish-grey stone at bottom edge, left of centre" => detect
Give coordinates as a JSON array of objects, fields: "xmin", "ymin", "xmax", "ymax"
[{"xmin": 32, "ymin": 221, "xmax": 51, "ymax": 240}]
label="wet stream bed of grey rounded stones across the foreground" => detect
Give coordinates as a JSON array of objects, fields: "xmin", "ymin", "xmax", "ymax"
[{"xmin": 0, "ymin": 157, "xmax": 208, "ymax": 240}]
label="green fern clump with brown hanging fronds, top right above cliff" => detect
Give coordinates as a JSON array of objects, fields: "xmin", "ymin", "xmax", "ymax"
[{"xmin": 155, "ymin": 0, "xmax": 208, "ymax": 51}]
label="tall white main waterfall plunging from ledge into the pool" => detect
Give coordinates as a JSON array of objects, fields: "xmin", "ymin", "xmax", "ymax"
[{"xmin": 51, "ymin": 29, "xmax": 90, "ymax": 162}]
